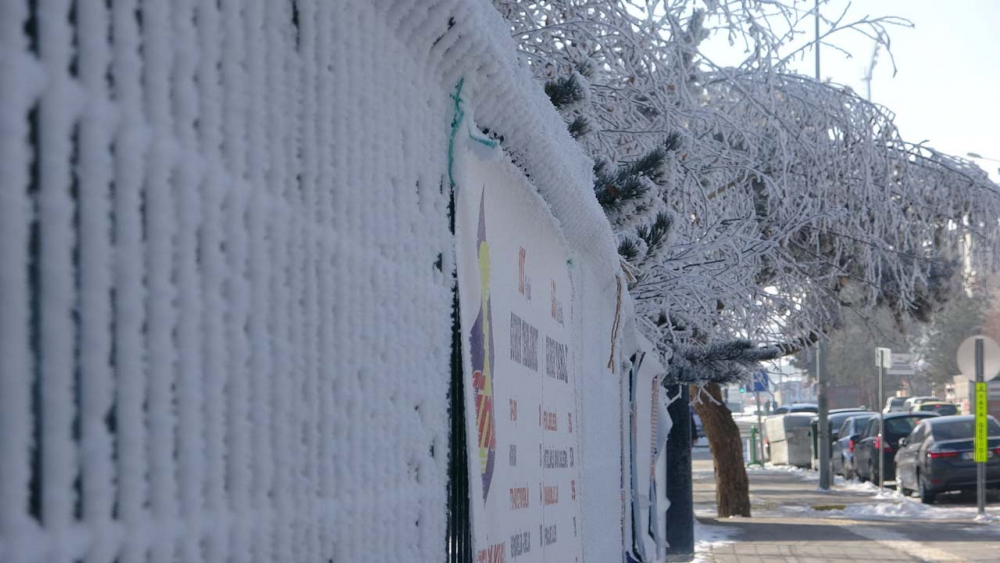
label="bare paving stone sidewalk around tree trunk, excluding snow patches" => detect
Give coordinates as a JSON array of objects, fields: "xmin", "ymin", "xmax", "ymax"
[{"xmin": 693, "ymin": 448, "xmax": 1000, "ymax": 563}]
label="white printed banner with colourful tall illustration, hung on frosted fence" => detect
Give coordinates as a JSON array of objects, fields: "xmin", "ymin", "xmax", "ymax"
[{"xmin": 455, "ymin": 143, "xmax": 582, "ymax": 563}]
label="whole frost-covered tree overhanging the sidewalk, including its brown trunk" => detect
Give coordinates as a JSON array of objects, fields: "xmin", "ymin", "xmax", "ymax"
[{"xmin": 494, "ymin": 0, "xmax": 1000, "ymax": 516}]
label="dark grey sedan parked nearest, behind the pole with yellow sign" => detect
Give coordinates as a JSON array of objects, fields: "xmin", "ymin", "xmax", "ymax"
[{"xmin": 896, "ymin": 415, "xmax": 1000, "ymax": 504}]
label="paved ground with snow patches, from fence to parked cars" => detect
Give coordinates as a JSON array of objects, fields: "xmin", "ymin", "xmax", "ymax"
[{"xmin": 693, "ymin": 423, "xmax": 1000, "ymax": 563}]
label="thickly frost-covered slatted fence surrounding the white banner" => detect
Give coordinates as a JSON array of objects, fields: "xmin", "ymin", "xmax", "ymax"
[{"xmin": 0, "ymin": 0, "xmax": 630, "ymax": 563}]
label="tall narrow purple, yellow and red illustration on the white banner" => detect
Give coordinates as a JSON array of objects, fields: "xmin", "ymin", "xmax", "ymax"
[{"xmin": 469, "ymin": 186, "xmax": 497, "ymax": 502}]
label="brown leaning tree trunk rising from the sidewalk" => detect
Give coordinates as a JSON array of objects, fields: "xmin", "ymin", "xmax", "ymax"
[{"xmin": 694, "ymin": 383, "xmax": 750, "ymax": 518}]
